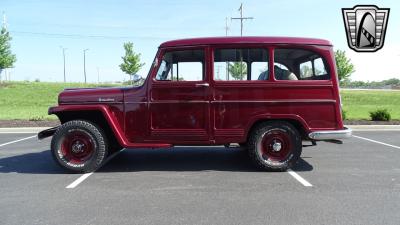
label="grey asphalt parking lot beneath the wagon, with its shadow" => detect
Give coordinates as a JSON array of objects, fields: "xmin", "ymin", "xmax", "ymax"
[{"xmin": 0, "ymin": 131, "xmax": 400, "ymax": 225}]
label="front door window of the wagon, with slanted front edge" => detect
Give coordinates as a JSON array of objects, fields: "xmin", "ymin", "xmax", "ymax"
[{"xmin": 156, "ymin": 50, "xmax": 204, "ymax": 81}]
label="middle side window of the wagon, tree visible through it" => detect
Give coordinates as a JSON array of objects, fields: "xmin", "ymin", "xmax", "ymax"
[{"xmin": 214, "ymin": 48, "xmax": 269, "ymax": 81}]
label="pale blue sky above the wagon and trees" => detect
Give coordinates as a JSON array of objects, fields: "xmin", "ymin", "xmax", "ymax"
[{"xmin": 0, "ymin": 0, "xmax": 400, "ymax": 82}]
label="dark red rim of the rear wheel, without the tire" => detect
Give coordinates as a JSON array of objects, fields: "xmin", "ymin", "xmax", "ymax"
[{"xmin": 258, "ymin": 129, "xmax": 293, "ymax": 161}]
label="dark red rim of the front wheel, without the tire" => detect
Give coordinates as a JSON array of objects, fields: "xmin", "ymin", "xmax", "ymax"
[{"xmin": 61, "ymin": 130, "xmax": 95, "ymax": 164}]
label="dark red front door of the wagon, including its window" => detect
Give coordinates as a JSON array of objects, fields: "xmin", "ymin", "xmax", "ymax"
[{"xmin": 149, "ymin": 48, "xmax": 210, "ymax": 143}]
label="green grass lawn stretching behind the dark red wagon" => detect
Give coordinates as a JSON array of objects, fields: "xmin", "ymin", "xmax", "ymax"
[{"xmin": 0, "ymin": 82, "xmax": 400, "ymax": 120}]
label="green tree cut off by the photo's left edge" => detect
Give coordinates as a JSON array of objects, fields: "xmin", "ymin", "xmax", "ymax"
[{"xmin": 0, "ymin": 27, "xmax": 17, "ymax": 81}]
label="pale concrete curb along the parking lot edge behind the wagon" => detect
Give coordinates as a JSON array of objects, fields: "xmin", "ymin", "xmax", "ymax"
[{"xmin": 0, "ymin": 125, "xmax": 400, "ymax": 134}]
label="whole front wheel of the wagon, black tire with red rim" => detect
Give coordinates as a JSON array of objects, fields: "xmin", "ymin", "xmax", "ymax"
[{"xmin": 51, "ymin": 120, "xmax": 108, "ymax": 173}]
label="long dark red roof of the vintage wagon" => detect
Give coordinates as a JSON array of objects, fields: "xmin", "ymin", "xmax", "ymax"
[{"xmin": 160, "ymin": 36, "xmax": 332, "ymax": 48}]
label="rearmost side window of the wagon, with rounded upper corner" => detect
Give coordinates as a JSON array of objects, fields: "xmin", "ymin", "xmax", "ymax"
[{"xmin": 274, "ymin": 48, "xmax": 330, "ymax": 80}]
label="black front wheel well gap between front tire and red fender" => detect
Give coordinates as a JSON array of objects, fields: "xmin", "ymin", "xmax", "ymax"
[{"xmin": 56, "ymin": 110, "xmax": 122, "ymax": 149}]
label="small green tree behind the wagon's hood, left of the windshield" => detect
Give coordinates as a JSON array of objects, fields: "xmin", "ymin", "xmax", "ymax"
[{"xmin": 119, "ymin": 42, "xmax": 144, "ymax": 82}]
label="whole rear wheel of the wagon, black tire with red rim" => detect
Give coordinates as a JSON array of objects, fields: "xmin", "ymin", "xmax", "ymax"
[{"xmin": 248, "ymin": 121, "xmax": 302, "ymax": 171}]
